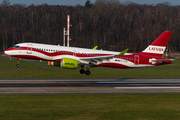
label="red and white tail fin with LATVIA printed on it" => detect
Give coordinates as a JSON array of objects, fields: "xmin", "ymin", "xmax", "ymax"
[{"xmin": 139, "ymin": 31, "xmax": 172, "ymax": 57}]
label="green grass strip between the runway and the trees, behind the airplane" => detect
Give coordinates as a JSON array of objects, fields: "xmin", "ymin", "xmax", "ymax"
[{"xmin": 0, "ymin": 59, "xmax": 180, "ymax": 78}]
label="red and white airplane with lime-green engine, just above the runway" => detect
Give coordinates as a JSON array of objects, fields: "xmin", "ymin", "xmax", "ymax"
[{"xmin": 4, "ymin": 31, "xmax": 173, "ymax": 75}]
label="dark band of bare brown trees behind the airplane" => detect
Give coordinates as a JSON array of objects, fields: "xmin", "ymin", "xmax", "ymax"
[{"xmin": 0, "ymin": 0, "xmax": 180, "ymax": 52}]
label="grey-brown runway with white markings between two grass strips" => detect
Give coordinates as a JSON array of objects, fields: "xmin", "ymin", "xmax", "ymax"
[{"xmin": 0, "ymin": 78, "xmax": 180, "ymax": 94}]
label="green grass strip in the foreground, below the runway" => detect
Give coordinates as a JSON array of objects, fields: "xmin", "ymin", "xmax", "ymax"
[{"xmin": 0, "ymin": 94, "xmax": 180, "ymax": 120}]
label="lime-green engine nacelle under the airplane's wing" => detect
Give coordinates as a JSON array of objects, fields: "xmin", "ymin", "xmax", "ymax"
[{"xmin": 61, "ymin": 58, "xmax": 78, "ymax": 69}]
